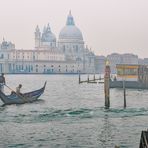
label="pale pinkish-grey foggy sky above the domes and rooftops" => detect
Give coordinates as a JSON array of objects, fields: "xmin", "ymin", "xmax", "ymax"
[{"xmin": 0, "ymin": 0, "xmax": 148, "ymax": 58}]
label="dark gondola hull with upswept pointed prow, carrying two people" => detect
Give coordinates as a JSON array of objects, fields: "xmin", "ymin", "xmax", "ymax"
[{"xmin": 0, "ymin": 82, "xmax": 46, "ymax": 105}]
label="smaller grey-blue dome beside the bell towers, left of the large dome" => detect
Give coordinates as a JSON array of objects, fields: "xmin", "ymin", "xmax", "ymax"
[{"xmin": 41, "ymin": 24, "xmax": 56, "ymax": 42}]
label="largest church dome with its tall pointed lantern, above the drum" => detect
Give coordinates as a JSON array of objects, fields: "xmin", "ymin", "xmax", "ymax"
[{"xmin": 59, "ymin": 12, "xmax": 83, "ymax": 40}]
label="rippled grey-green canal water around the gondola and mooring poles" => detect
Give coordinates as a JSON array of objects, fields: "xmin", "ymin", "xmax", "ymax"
[{"xmin": 0, "ymin": 75, "xmax": 148, "ymax": 148}]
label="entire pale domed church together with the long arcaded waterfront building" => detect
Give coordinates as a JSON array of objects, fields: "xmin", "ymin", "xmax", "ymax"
[{"xmin": 0, "ymin": 12, "xmax": 95, "ymax": 74}]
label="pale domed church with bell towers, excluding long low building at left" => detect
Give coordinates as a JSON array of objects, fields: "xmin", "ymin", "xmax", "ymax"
[{"xmin": 35, "ymin": 11, "xmax": 95, "ymax": 72}]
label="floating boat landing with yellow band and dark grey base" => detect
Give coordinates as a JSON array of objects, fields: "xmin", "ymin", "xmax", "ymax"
[{"xmin": 110, "ymin": 64, "xmax": 148, "ymax": 89}]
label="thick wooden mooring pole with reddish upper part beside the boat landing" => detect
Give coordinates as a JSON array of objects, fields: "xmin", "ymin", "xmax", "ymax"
[{"xmin": 104, "ymin": 65, "xmax": 110, "ymax": 109}]
